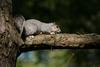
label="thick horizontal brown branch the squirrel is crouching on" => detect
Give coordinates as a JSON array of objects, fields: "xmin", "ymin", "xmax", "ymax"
[{"xmin": 21, "ymin": 34, "xmax": 100, "ymax": 49}]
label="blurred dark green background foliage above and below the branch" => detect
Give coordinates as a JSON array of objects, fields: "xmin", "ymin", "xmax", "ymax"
[{"xmin": 13, "ymin": 0, "xmax": 100, "ymax": 67}]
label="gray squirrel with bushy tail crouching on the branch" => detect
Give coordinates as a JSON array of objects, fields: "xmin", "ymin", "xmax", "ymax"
[{"xmin": 14, "ymin": 16, "xmax": 61, "ymax": 36}]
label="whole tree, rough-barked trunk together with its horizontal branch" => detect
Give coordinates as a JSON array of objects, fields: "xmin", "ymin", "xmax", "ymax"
[{"xmin": 0, "ymin": 0, "xmax": 100, "ymax": 67}]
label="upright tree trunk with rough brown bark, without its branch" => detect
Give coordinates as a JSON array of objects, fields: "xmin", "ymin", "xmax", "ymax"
[{"xmin": 0, "ymin": 0, "xmax": 22, "ymax": 67}]
